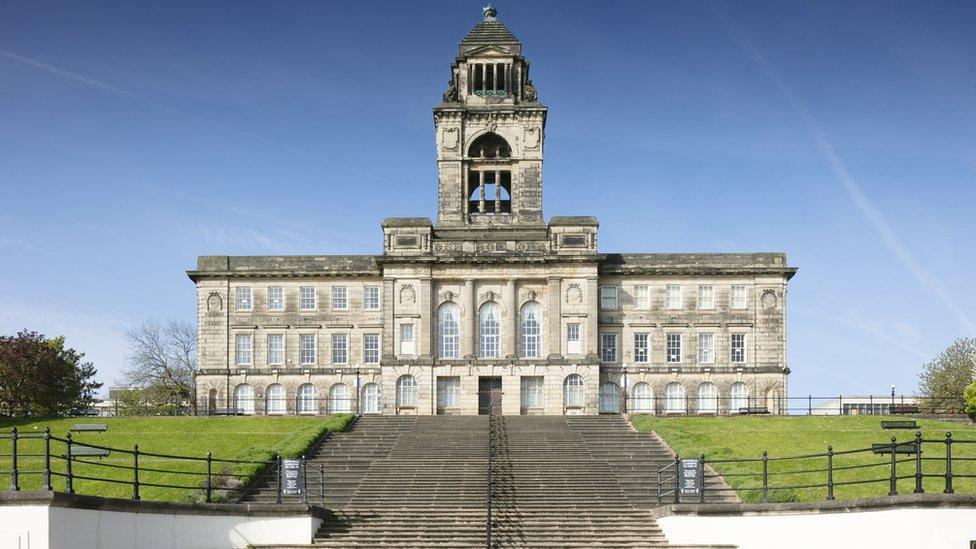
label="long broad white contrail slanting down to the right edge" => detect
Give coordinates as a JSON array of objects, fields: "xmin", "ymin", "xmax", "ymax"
[{"xmin": 719, "ymin": 15, "xmax": 976, "ymax": 334}]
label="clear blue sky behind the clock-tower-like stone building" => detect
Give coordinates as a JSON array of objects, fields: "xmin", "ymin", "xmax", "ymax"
[{"xmin": 0, "ymin": 1, "xmax": 976, "ymax": 396}]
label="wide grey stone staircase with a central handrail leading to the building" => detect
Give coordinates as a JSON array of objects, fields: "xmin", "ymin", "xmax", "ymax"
[{"xmin": 250, "ymin": 416, "xmax": 736, "ymax": 548}]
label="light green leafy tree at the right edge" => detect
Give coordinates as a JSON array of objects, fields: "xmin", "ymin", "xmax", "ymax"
[{"xmin": 918, "ymin": 337, "xmax": 976, "ymax": 413}]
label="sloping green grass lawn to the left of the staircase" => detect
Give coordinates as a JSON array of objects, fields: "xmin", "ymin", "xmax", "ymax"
[{"xmin": 0, "ymin": 414, "xmax": 353, "ymax": 502}]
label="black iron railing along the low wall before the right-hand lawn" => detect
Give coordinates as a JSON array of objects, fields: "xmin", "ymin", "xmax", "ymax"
[{"xmin": 656, "ymin": 431, "xmax": 976, "ymax": 505}]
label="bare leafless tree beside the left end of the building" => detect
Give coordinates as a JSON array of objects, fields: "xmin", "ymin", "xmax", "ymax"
[{"xmin": 123, "ymin": 319, "xmax": 197, "ymax": 414}]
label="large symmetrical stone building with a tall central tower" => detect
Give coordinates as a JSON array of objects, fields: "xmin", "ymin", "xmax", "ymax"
[{"xmin": 187, "ymin": 7, "xmax": 796, "ymax": 414}]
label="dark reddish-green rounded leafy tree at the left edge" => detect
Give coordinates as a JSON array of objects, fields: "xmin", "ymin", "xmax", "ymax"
[{"xmin": 0, "ymin": 330, "xmax": 102, "ymax": 416}]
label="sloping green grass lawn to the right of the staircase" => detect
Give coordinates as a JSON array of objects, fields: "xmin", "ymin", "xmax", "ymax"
[{"xmin": 631, "ymin": 415, "xmax": 976, "ymax": 502}]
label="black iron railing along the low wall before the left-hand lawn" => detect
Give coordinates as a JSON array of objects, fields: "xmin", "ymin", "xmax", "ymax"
[{"xmin": 0, "ymin": 427, "xmax": 325, "ymax": 504}]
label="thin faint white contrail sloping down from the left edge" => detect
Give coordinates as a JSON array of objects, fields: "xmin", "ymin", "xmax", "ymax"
[{"xmin": 0, "ymin": 49, "xmax": 397, "ymax": 187}]
